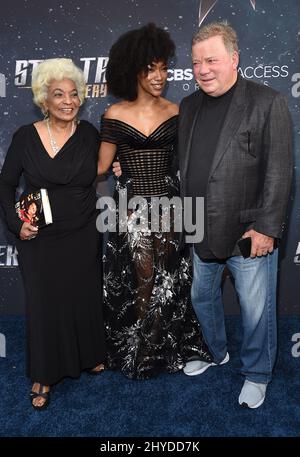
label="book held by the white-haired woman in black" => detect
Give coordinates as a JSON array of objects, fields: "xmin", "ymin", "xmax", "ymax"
[{"xmin": 15, "ymin": 189, "xmax": 53, "ymax": 228}]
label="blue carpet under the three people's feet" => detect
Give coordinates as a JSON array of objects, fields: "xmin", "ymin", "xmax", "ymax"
[{"xmin": 0, "ymin": 316, "xmax": 300, "ymax": 437}]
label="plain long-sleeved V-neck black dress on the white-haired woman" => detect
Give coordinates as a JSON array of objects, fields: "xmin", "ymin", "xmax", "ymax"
[{"xmin": 0, "ymin": 121, "xmax": 105, "ymax": 385}]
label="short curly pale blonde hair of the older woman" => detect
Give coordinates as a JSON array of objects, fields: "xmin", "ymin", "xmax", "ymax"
[{"xmin": 31, "ymin": 58, "xmax": 86, "ymax": 113}]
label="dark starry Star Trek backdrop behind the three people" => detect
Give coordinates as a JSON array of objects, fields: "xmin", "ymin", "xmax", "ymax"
[{"xmin": 0, "ymin": 0, "xmax": 300, "ymax": 314}]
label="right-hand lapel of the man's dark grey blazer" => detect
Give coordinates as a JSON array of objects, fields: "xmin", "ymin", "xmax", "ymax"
[{"xmin": 209, "ymin": 76, "xmax": 247, "ymax": 178}]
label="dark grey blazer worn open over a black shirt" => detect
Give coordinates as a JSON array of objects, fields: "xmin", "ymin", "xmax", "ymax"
[{"xmin": 178, "ymin": 76, "xmax": 293, "ymax": 258}]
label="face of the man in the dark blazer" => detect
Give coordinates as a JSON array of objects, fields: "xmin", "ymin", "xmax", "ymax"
[{"xmin": 192, "ymin": 35, "xmax": 239, "ymax": 97}]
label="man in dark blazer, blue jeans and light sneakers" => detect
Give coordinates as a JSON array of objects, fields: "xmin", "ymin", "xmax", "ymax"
[{"xmin": 178, "ymin": 23, "xmax": 292, "ymax": 408}]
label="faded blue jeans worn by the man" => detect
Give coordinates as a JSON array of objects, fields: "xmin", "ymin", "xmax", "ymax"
[{"xmin": 191, "ymin": 249, "xmax": 278, "ymax": 383}]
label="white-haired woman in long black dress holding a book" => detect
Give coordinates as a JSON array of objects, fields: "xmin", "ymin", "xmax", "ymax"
[{"xmin": 0, "ymin": 59, "xmax": 105, "ymax": 410}]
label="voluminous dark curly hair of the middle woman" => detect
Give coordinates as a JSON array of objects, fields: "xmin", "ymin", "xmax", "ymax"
[{"xmin": 106, "ymin": 23, "xmax": 175, "ymax": 101}]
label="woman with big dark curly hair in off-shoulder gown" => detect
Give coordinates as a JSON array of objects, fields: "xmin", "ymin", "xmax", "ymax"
[{"xmin": 98, "ymin": 24, "xmax": 211, "ymax": 379}]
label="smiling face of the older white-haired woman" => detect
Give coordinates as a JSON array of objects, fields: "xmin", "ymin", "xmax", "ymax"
[{"xmin": 44, "ymin": 79, "xmax": 80, "ymax": 122}]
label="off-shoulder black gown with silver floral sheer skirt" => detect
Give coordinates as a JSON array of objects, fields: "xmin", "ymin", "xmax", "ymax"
[{"xmin": 100, "ymin": 116, "xmax": 211, "ymax": 379}]
